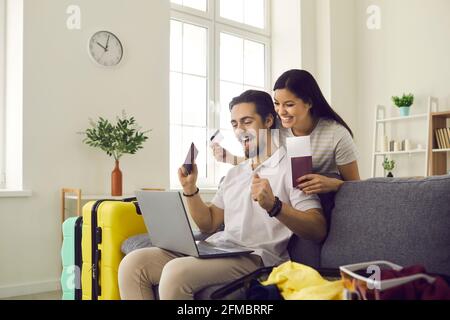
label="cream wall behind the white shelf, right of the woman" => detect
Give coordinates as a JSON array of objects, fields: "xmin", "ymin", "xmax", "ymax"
[{"xmin": 356, "ymin": 0, "xmax": 450, "ymax": 178}]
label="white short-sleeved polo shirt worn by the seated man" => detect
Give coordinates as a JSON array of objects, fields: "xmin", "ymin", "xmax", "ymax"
[{"xmin": 207, "ymin": 147, "xmax": 321, "ymax": 266}]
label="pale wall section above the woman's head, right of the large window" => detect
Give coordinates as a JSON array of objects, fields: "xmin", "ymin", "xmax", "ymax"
[{"xmin": 272, "ymin": 0, "xmax": 357, "ymax": 141}]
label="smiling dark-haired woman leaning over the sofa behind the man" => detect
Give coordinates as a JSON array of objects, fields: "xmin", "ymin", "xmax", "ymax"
[{"xmin": 212, "ymin": 70, "xmax": 360, "ymax": 195}]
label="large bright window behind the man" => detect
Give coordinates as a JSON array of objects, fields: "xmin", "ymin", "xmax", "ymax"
[{"xmin": 170, "ymin": 0, "xmax": 270, "ymax": 188}]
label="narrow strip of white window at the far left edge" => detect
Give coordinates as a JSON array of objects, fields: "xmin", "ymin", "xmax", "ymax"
[{"xmin": 0, "ymin": 0, "xmax": 24, "ymax": 192}]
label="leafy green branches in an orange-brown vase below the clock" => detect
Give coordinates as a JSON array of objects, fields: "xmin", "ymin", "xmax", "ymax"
[{"xmin": 80, "ymin": 112, "xmax": 151, "ymax": 197}]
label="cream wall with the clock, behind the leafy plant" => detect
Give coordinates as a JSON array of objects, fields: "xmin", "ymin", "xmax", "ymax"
[{"xmin": 0, "ymin": 0, "xmax": 169, "ymax": 297}]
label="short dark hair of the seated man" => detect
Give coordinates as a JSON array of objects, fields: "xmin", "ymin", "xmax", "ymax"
[{"xmin": 230, "ymin": 90, "xmax": 277, "ymax": 129}]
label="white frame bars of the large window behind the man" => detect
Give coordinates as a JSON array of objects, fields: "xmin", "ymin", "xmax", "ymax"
[{"xmin": 171, "ymin": 0, "xmax": 272, "ymax": 189}]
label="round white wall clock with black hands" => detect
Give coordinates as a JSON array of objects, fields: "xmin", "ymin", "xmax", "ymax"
[{"xmin": 89, "ymin": 31, "xmax": 123, "ymax": 67}]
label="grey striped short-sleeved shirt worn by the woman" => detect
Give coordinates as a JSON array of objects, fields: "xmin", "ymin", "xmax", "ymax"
[{"xmin": 280, "ymin": 118, "xmax": 358, "ymax": 175}]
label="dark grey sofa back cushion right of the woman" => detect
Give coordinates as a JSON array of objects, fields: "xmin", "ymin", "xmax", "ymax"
[{"xmin": 321, "ymin": 176, "xmax": 450, "ymax": 274}]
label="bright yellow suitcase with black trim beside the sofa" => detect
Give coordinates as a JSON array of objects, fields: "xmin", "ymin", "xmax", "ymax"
[{"xmin": 81, "ymin": 199, "xmax": 147, "ymax": 300}]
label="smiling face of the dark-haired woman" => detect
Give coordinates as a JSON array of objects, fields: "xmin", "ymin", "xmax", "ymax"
[{"xmin": 274, "ymin": 89, "xmax": 311, "ymax": 129}]
